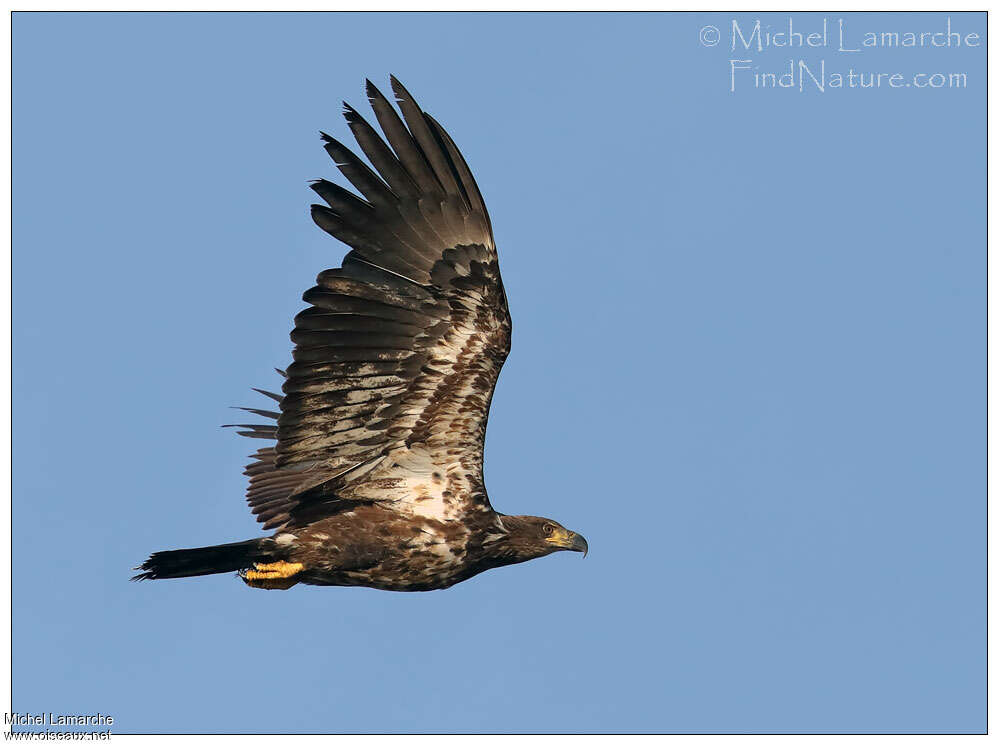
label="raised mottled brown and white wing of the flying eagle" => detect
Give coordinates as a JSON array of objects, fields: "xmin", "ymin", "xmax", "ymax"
[{"xmin": 237, "ymin": 78, "xmax": 510, "ymax": 528}]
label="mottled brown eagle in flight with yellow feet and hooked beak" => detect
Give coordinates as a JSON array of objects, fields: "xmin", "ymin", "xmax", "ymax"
[{"xmin": 133, "ymin": 76, "xmax": 588, "ymax": 591}]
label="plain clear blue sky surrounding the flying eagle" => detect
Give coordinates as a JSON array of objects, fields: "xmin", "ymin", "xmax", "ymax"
[{"xmin": 13, "ymin": 14, "xmax": 986, "ymax": 732}]
